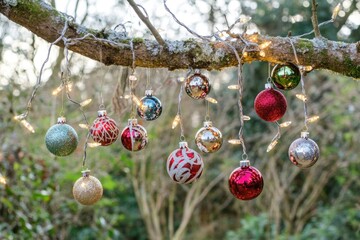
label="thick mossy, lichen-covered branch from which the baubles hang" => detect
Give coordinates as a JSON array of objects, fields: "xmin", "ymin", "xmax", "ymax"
[{"xmin": 0, "ymin": 0, "xmax": 360, "ymax": 78}]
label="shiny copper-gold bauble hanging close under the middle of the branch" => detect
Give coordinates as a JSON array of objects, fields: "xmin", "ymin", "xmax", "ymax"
[{"xmin": 185, "ymin": 70, "xmax": 211, "ymax": 99}]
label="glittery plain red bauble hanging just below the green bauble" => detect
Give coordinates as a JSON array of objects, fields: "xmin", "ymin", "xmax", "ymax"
[{"xmin": 254, "ymin": 83, "xmax": 287, "ymax": 122}]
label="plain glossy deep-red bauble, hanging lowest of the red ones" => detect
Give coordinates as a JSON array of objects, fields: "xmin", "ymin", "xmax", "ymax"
[{"xmin": 229, "ymin": 160, "xmax": 264, "ymax": 200}]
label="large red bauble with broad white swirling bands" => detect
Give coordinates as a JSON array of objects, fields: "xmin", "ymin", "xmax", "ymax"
[{"xmin": 166, "ymin": 142, "xmax": 204, "ymax": 184}]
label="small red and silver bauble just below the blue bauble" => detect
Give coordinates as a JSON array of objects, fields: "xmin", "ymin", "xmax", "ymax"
[{"xmin": 121, "ymin": 119, "xmax": 148, "ymax": 152}]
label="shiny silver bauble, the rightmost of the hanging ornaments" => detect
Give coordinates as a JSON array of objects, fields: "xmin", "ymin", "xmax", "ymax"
[{"xmin": 288, "ymin": 132, "xmax": 320, "ymax": 168}]
